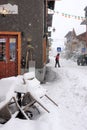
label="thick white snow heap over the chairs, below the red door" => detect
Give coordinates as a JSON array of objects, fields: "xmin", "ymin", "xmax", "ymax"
[{"xmin": 0, "ymin": 72, "xmax": 46, "ymax": 108}]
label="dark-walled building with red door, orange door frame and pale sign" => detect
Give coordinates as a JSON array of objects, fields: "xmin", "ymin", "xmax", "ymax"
[{"xmin": 0, "ymin": 0, "xmax": 55, "ymax": 82}]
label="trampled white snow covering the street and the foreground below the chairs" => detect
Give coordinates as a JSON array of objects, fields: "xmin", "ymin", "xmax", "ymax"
[{"xmin": 0, "ymin": 50, "xmax": 87, "ymax": 130}]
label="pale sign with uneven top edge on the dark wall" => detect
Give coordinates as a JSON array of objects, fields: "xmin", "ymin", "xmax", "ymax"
[{"xmin": 0, "ymin": 3, "xmax": 18, "ymax": 14}]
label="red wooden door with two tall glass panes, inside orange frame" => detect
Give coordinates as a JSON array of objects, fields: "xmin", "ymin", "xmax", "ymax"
[{"xmin": 0, "ymin": 35, "xmax": 18, "ymax": 78}]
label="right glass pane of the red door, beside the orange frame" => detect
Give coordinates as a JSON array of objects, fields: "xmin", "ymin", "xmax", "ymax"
[{"xmin": 9, "ymin": 38, "xmax": 16, "ymax": 61}]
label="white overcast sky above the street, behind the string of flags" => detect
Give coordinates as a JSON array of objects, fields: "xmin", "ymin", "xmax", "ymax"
[{"xmin": 52, "ymin": 0, "xmax": 87, "ymax": 46}]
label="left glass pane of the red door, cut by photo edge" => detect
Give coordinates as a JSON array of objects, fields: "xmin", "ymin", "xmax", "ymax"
[{"xmin": 0, "ymin": 38, "xmax": 6, "ymax": 61}]
